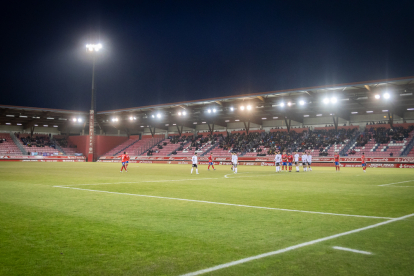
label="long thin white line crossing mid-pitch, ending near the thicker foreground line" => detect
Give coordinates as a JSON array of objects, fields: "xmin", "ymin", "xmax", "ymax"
[{"xmin": 53, "ymin": 186, "xmax": 393, "ymax": 219}]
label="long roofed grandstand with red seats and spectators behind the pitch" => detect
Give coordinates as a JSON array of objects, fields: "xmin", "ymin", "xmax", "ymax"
[{"xmin": 0, "ymin": 77, "xmax": 414, "ymax": 161}]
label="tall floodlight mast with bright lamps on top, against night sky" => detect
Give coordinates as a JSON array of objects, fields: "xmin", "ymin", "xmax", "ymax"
[{"xmin": 86, "ymin": 43, "xmax": 102, "ymax": 162}]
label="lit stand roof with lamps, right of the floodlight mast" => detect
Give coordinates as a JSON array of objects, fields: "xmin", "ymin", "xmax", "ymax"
[{"xmin": 97, "ymin": 76, "xmax": 414, "ymax": 129}]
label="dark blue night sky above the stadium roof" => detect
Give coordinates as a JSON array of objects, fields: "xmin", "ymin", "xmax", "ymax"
[{"xmin": 0, "ymin": 0, "xmax": 414, "ymax": 110}]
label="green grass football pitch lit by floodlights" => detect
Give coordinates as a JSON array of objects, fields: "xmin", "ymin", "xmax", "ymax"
[{"xmin": 0, "ymin": 162, "xmax": 414, "ymax": 275}]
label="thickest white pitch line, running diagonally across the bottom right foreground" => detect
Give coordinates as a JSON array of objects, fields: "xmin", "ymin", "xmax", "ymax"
[{"xmin": 181, "ymin": 214, "xmax": 414, "ymax": 276}]
